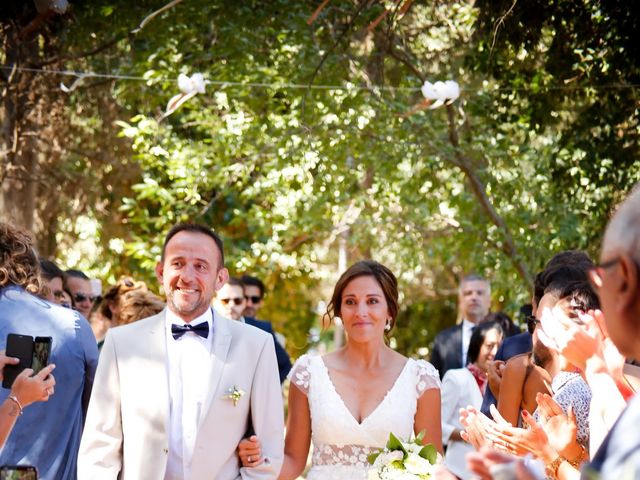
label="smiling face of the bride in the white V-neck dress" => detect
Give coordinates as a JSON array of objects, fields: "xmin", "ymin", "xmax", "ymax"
[{"xmin": 340, "ymin": 276, "xmax": 390, "ymax": 342}]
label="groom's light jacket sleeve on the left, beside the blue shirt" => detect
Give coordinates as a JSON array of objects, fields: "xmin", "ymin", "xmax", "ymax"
[{"xmin": 78, "ymin": 332, "xmax": 122, "ymax": 480}]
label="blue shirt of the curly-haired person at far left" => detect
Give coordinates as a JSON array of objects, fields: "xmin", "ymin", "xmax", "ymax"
[{"xmin": 0, "ymin": 286, "xmax": 98, "ymax": 480}]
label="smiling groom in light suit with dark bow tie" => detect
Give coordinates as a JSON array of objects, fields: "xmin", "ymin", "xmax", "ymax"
[{"xmin": 78, "ymin": 224, "xmax": 284, "ymax": 480}]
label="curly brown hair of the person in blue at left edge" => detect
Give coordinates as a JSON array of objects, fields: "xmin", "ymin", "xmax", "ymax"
[{"xmin": 0, "ymin": 222, "xmax": 41, "ymax": 295}]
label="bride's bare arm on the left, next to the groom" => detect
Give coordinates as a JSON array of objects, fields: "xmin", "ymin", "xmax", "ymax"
[{"xmin": 278, "ymin": 382, "xmax": 311, "ymax": 480}]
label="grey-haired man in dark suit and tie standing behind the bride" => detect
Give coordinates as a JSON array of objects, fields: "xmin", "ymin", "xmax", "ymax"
[{"xmin": 431, "ymin": 275, "xmax": 491, "ymax": 378}]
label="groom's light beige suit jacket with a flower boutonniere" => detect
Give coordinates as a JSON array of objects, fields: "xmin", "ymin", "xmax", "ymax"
[{"xmin": 78, "ymin": 311, "xmax": 284, "ymax": 480}]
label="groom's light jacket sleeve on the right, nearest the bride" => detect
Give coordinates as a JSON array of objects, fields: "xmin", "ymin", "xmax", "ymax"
[{"xmin": 240, "ymin": 337, "xmax": 284, "ymax": 480}]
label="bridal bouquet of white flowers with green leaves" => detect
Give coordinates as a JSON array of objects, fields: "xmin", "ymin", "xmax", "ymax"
[{"xmin": 367, "ymin": 432, "xmax": 438, "ymax": 480}]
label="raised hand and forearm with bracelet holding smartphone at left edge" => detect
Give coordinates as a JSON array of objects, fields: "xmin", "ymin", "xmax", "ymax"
[{"xmin": 0, "ymin": 352, "xmax": 56, "ymax": 448}]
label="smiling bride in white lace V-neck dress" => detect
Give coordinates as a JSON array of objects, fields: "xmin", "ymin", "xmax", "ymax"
[{"xmin": 238, "ymin": 260, "xmax": 442, "ymax": 480}]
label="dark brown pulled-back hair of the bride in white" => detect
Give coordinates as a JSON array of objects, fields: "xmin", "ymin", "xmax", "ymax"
[{"xmin": 323, "ymin": 260, "xmax": 399, "ymax": 328}]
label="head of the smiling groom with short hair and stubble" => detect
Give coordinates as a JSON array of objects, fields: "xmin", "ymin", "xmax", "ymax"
[{"xmin": 156, "ymin": 230, "xmax": 229, "ymax": 322}]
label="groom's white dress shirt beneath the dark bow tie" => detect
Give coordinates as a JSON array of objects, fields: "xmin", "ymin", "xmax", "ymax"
[{"xmin": 164, "ymin": 308, "xmax": 213, "ymax": 480}]
